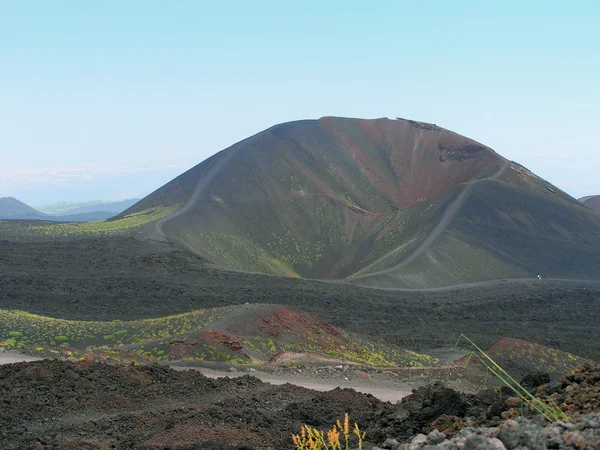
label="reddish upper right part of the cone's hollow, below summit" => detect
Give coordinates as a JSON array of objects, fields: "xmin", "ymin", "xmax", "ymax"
[{"xmin": 320, "ymin": 118, "xmax": 501, "ymax": 209}]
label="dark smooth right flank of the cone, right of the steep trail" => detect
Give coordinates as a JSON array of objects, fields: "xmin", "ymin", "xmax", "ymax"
[{"xmin": 349, "ymin": 172, "xmax": 600, "ymax": 288}]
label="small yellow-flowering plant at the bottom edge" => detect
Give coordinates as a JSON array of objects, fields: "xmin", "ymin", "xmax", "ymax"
[{"xmin": 292, "ymin": 413, "xmax": 366, "ymax": 450}]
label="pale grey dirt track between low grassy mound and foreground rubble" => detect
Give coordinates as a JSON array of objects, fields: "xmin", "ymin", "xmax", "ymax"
[{"xmin": 172, "ymin": 366, "xmax": 411, "ymax": 403}]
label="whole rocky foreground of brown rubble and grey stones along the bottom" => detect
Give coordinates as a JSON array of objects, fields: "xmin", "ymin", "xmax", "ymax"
[{"xmin": 0, "ymin": 360, "xmax": 600, "ymax": 450}]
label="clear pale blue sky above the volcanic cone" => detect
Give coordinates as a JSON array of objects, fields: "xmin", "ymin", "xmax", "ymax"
[{"xmin": 0, "ymin": 0, "xmax": 600, "ymax": 206}]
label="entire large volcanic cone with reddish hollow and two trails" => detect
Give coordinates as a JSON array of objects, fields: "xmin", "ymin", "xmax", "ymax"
[{"xmin": 117, "ymin": 117, "xmax": 600, "ymax": 287}]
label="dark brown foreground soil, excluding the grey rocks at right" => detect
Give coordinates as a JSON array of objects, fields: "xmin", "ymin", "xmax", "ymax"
[{"xmin": 0, "ymin": 360, "xmax": 516, "ymax": 450}]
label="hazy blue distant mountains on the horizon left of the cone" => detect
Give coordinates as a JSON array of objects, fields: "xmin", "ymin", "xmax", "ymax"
[{"xmin": 0, "ymin": 197, "xmax": 138, "ymax": 222}]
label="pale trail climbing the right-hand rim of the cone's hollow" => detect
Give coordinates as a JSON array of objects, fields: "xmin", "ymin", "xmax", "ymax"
[{"xmin": 348, "ymin": 161, "xmax": 510, "ymax": 281}]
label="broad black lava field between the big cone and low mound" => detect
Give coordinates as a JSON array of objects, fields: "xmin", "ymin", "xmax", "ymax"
[{"xmin": 0, "ymin": 238, "xmax": 600, "ymax": 359}]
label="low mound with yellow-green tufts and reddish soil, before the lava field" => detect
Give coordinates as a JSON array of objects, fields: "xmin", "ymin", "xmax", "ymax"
[{"xmin": 0, "ymin": 304, "xmax": 436, "ymax": 367}]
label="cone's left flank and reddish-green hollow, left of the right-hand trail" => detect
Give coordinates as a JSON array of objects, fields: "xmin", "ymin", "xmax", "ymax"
[{"xmin": 124, "ymin": 118, "xmax": 504, "ymax": 278}]
